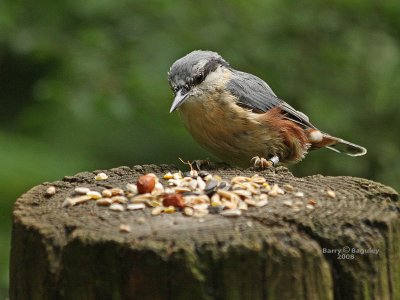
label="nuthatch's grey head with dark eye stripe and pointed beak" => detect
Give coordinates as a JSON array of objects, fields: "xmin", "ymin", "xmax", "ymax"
[{"xmin": 168, "ymin": 50, "xmax": 229, "ymax": 112}]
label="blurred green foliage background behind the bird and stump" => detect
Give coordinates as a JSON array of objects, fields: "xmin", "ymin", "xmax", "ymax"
[{"xmin": 0, "ymin": 0, "xmax": 400, "ymax": 299}]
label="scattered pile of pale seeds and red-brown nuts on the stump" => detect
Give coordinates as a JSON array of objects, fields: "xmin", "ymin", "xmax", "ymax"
[{"xmin": 58, "ymin": 170, "xmax": 336, "ymax": 218}]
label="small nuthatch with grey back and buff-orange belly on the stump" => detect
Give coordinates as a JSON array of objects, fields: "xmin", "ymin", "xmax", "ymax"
[{"xmin": 168, "ymin": 50, "xmax": 367, "ymax": 169}]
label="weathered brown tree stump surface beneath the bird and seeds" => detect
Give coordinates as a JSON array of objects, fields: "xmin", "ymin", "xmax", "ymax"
[{"xmin": 10, "ymin": 165, "xmax": 400, "ymax": 300}]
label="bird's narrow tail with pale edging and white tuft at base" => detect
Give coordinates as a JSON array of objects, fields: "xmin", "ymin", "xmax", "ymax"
[{"xmin": 308, "ymin": 129, "xmax": 367, "ymax": 156}]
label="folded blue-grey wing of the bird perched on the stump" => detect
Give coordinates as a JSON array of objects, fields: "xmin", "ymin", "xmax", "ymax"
[{"xmin": 227, "ymin": 70, "xmax": 315, "ymax": 128}]
